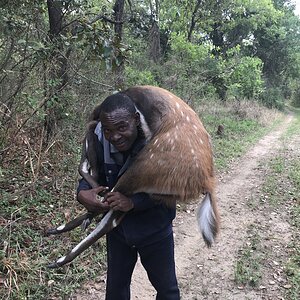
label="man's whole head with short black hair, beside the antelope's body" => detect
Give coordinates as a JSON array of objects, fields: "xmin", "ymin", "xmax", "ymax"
[{"xmin": 99, "ymin": 93, "xmax": 140, "ymax": 152}]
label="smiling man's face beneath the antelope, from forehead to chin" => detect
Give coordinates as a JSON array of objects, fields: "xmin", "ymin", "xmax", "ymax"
[{"xmin": 100, "ymin": 108, "xmax": 140, "ymax": 152}]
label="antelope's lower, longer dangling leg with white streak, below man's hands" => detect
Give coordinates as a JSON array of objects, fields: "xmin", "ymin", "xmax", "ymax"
[{"xmin": 48, "ymin": 209, "xmax": 126, "ymax": 269}]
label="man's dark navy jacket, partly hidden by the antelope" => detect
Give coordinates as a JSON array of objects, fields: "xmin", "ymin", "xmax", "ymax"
[{"xmin": 77, "ymin": 125, "xmax": 176, "ymax": 246}]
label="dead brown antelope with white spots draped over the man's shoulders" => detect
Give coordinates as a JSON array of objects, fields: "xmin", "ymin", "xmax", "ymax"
[{"xmin": 48, "ymin": 86, "xmax": 219, "ymax": 268}]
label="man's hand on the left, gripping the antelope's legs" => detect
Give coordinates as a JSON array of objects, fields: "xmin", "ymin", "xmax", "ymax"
[{"xmin": 77, "ymin": 186, "xmax": 110, "ymax": 213}]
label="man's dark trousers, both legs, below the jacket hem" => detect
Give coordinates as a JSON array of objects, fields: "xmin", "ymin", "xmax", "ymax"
[{"xmin": 105, "ymin": 233, "xmax": 180, "ymax": 300}]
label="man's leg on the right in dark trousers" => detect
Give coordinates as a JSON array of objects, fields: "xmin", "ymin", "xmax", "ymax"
[{"xmin": 138, "ymin": 233, "xmax": 180, "ymax": 300}]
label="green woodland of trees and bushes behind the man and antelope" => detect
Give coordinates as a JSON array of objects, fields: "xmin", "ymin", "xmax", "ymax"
[{"xmin": 0, "ymin": 0, "xmax": 300, "ymax": 145}]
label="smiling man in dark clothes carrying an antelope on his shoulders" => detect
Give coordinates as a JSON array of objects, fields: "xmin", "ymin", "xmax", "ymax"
[{"xmin": 78, "ymin": 93, "xmax": 180, "ymax": 300}]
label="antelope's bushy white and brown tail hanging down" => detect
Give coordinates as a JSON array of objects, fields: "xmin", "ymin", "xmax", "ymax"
[{"xmin": 197, "ymin": 193, "xmax": 220, "ymax": 247}]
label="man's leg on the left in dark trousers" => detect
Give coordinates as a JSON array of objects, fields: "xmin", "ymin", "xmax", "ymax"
[{"xmin": 105, "ymin": 233, "xmax": 137, "ymax": 300}]
